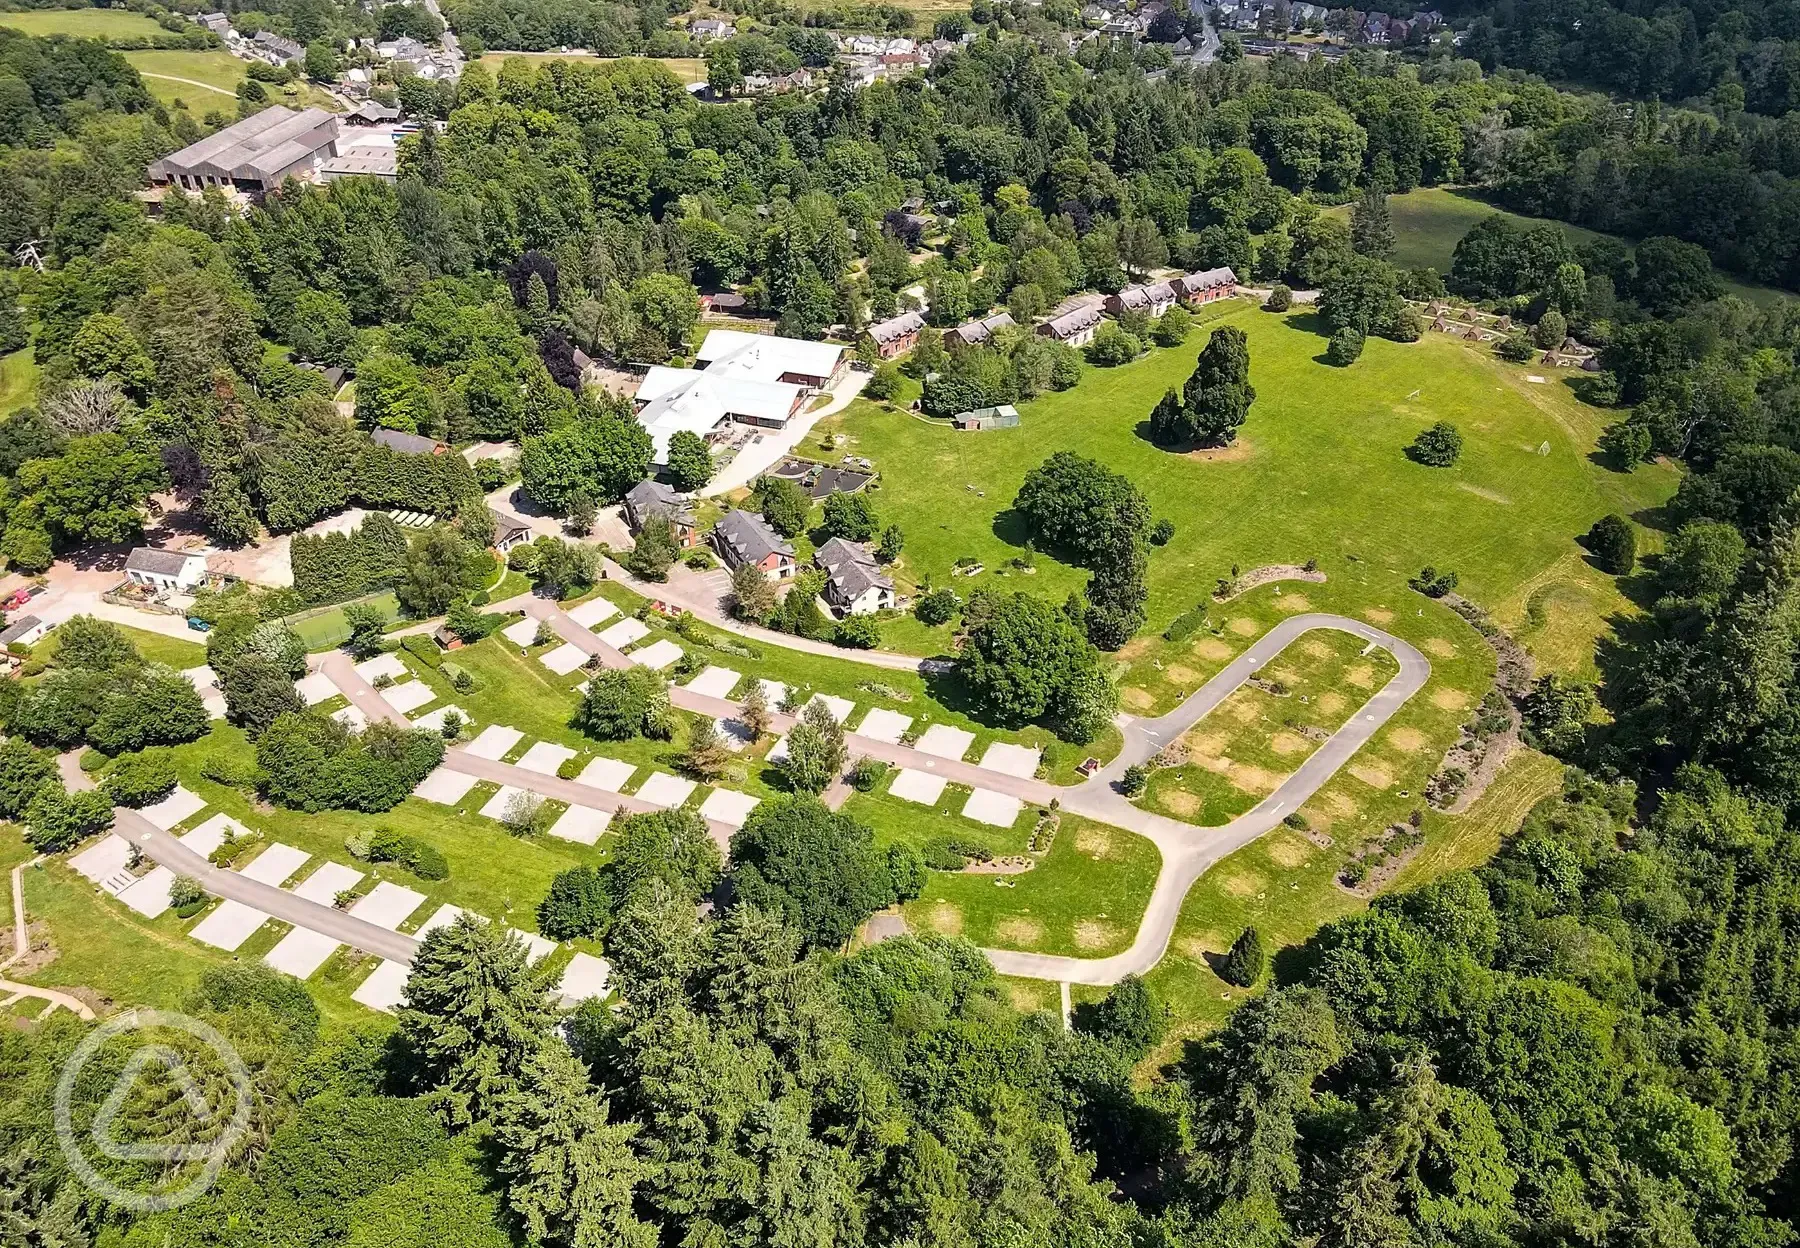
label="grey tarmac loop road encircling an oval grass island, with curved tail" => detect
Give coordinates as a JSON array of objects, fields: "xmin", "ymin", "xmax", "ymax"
[{"xmin": 983, "ymin": 614, "xmax": 1431, "ymax": 983}]
